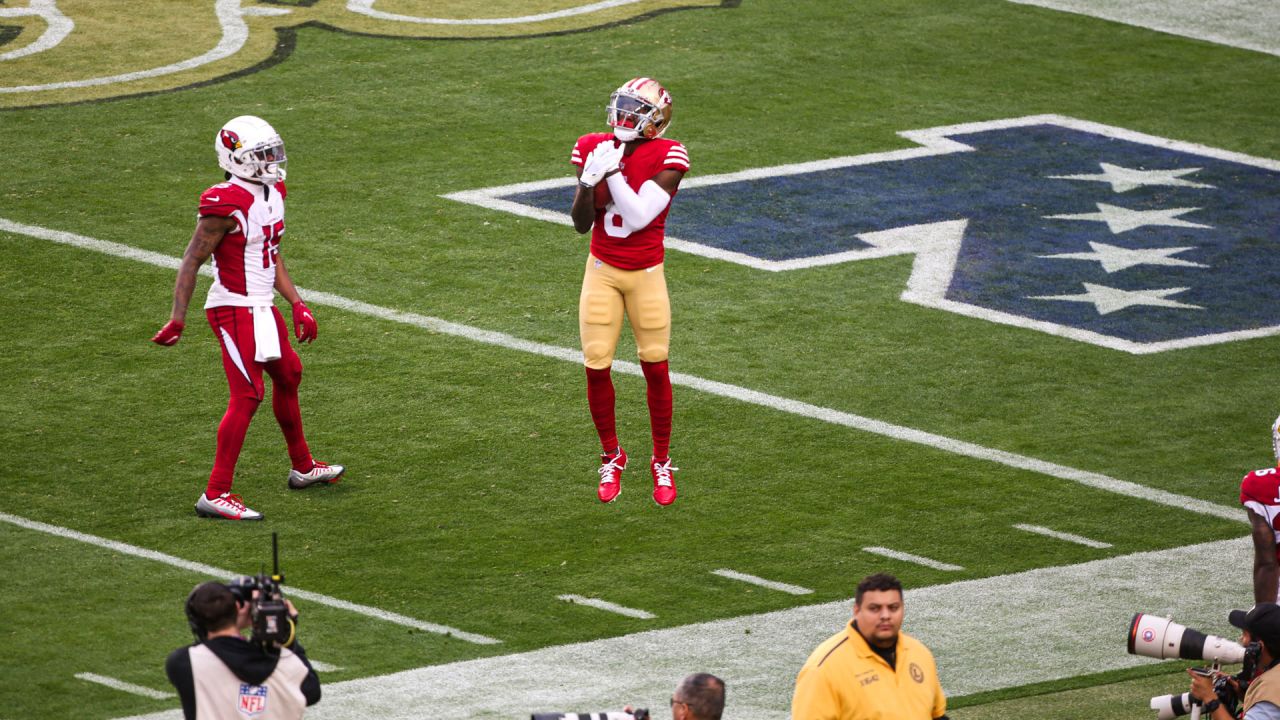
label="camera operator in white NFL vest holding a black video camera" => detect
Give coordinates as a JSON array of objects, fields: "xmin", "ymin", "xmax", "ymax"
[{"xmin": 165, "ymin": 582, "xmax": 320, "ymax": 720}]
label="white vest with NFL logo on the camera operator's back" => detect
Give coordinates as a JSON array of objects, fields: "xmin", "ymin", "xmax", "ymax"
[{"xmin": 188, "ymin": 644, "xmax": 307, "ymax": 720}]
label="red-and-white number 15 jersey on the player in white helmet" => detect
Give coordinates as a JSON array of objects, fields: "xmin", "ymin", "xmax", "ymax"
[{"xmin": 198, "ymin": 177, "xmax": 285, "ymax": 309}]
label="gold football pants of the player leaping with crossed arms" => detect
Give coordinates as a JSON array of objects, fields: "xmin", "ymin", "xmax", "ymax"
[{"xmin": 577, "ymin": 254, "xmax": 671, "ymax": 370}]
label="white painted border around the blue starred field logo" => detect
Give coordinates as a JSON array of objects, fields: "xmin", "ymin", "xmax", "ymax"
[{"xmin": 442, "ymin": 114, "xmax": 1280, "ymax": 355}]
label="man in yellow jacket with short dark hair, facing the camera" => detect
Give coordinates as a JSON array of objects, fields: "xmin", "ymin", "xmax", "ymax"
[{"xmin": 791, "ymin": 574, "xmax": 947, "ymax": 720}]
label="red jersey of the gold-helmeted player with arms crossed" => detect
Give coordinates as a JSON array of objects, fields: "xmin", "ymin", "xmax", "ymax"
[{"xmin": 570, "ymin": 132, "xmax": 689, "ymax": 270}]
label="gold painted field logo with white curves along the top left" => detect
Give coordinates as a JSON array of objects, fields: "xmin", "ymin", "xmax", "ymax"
[{"xmin": 0, "ymin": 0, "xmax": 740, "ymax": 108}]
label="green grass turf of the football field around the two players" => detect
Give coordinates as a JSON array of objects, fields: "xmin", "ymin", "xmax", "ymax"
[{"xmin": 0, "ymin": 0, "xmax": 1280, "ymax": 719}]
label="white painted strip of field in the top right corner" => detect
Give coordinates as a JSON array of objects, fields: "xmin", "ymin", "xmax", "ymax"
[{"xmin": 1009, "ymin": 0, "xmax": 1280, "ymax": 55}]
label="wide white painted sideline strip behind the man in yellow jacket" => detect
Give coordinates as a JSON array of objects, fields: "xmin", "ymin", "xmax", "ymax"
[{"xmin": 107, "ymin": 534, "xmax": 1253, "ymax": 720}]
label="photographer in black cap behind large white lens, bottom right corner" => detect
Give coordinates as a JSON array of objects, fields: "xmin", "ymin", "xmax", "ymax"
[{"xmin": 1187, "ymin": 602, "xmax": 1280, "ymax": 720}]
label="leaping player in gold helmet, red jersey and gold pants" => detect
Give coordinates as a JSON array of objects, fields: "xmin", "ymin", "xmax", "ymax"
[{"xmin": 570, "ymin": 77, "xmax": 689, "ymax": 505}]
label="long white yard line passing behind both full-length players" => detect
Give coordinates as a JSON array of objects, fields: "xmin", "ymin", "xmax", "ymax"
[{"xmin": 0, "ymin": 212, "xmax": 1245, "ymax": 523}]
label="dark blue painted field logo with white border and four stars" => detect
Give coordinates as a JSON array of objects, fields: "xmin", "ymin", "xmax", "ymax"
[{"xmin": 449, "ymin": 115, "xmax": 1280, "ymax": 354}]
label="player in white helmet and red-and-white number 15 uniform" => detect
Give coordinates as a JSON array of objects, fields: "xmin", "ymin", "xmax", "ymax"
[{"xmin": 151, "ymin": 115, "xmax": 344, "ymax": 520}]
